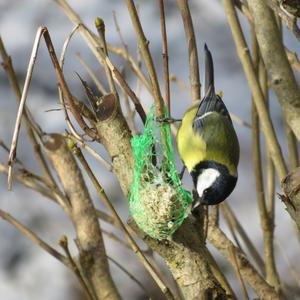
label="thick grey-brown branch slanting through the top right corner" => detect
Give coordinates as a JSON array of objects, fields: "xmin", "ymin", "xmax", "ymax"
[{"xmin": 248, "ymin": 0, "xmax": 300, "ymax": 140}]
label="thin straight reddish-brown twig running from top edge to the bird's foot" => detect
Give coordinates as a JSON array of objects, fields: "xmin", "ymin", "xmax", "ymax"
[{"xmin": 158, "ymin": 0, "xmax": 171, "ymax": 115}]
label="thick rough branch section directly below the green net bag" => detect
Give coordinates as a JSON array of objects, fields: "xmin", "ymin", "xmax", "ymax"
[{"xmin": 129, "ymin": 219, "xmax": 226, "ymax": 299}]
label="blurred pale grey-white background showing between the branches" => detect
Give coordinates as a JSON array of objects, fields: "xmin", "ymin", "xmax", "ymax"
[{"xmin": 0, "ymin": 0, "xmax": 300, "ymax": 300}]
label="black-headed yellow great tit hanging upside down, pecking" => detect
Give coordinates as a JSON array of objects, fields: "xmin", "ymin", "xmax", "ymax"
[{"xmin": 176, "ymin": 44, "xmax": 240, "ymax": 211}]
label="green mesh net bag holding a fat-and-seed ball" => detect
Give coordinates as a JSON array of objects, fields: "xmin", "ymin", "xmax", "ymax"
[{"xmin": 129, "ymin": 108, "xmax": 192, "ymax": 240}]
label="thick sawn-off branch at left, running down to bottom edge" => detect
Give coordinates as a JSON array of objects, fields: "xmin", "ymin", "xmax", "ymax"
[{"xmin": 45, "ymin": 134, "xmax": 121, "ymax": 300}]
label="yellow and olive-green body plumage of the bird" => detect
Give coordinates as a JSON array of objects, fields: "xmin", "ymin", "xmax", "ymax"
[{"xmin": 176, "ymin": 103, "xmax": 239, "ymax": 175}]
